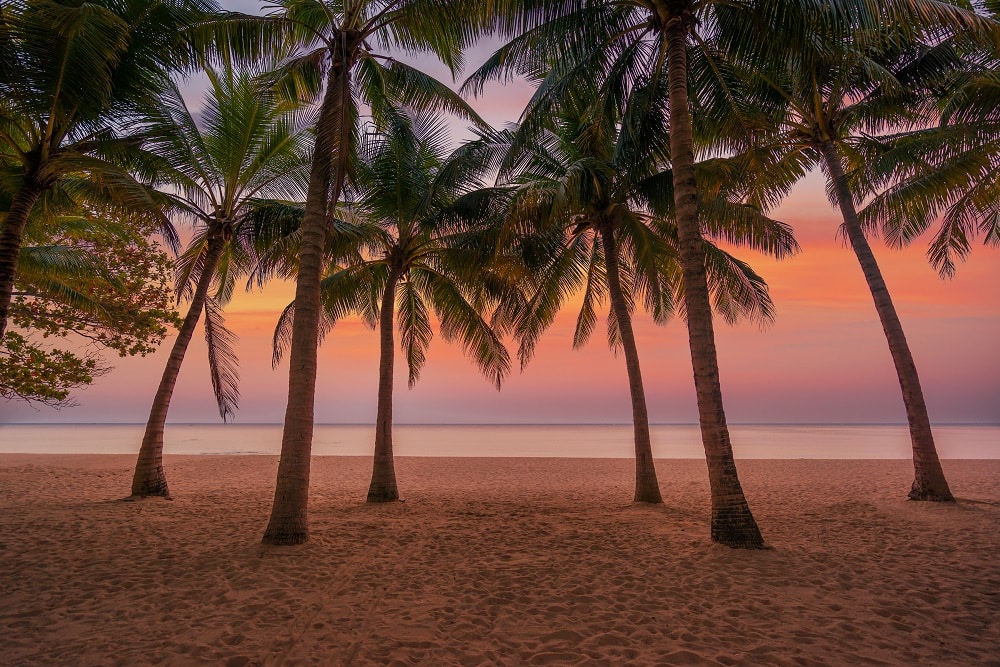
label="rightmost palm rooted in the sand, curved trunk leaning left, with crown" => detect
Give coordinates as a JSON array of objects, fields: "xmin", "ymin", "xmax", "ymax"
[{"xmin": 732, "ymin": 10, "xmax": 996, "ymax": 501}]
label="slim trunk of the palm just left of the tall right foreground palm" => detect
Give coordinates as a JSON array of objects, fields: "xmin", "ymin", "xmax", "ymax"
[{"xmin": 599, "ymin": 222, "xmax": 663, "ymax": 503}]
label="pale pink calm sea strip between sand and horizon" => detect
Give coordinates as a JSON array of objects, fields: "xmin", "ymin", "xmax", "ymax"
[{"xmin": 0, "ymin": 424, "xmax": 1000, "ymax": 459}]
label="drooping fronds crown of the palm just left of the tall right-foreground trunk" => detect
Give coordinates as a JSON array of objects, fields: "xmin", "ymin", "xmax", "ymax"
[{"xmin": 501, "ymin": 82, "xmax": 798, "ymax": 364}]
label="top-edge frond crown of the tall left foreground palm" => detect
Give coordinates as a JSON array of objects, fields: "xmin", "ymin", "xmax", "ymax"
[{"xmin": 195, "ymin": 0, "xmax": 482, "ymax": 124}]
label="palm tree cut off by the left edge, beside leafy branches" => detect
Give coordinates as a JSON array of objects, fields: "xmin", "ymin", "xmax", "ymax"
[{"xmin": 0, "ymin": 0, "xmax": 215, "ymax": 335}]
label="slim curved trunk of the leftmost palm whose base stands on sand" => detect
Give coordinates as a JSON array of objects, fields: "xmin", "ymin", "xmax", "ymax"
[{"xmin": 132, "ymin": 237, "xmax": 224, "ymax": 498}]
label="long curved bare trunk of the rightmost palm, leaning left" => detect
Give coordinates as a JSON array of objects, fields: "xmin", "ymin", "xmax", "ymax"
[{"xmin": 822, "ymin": 141, "xmax": 955, "ymax": 501}]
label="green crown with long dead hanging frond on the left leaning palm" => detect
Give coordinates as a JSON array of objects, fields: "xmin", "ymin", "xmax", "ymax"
[{"xmin": 142, "ymin": 61, "xmax": 313, "ymax": 419}]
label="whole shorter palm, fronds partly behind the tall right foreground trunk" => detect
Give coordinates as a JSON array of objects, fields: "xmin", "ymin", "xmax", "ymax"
[{"xmin": 500, "ymin": 87, "xmax": 797, "ymax": 503}]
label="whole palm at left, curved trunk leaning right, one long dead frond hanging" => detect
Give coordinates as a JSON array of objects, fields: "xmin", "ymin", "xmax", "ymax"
[{"xmin": 132, "ymin": 62, "xmax": 312, "ymax": 497}]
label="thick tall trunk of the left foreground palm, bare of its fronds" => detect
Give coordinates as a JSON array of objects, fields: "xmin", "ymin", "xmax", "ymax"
[{"xmin": 262, "ymin": 51, "xmax": 353, "ymax": 545}]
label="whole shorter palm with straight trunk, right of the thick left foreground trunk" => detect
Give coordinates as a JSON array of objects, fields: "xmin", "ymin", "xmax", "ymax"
[{"xmin": 275, "ymin": 113, "xmax": 510, "ymax": 502}]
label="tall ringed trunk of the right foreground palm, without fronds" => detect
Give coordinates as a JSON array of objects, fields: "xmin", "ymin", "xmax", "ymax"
[{"xmin": 666, "ymin": 17, "xmax": 764, "ymax": 549}]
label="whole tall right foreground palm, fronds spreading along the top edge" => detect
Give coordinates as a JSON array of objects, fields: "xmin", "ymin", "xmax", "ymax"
[{"xmin": 466, "ymin": 0, "xmax": 1000, "ymax": 548}]
